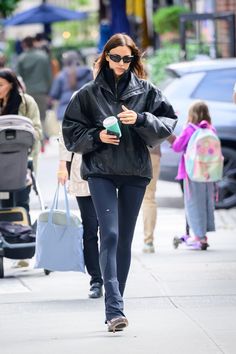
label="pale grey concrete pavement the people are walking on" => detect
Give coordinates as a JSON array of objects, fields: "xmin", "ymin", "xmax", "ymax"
[{"xmin": 0, "ymin": 137, "xmax": 236, "ymax": 354}]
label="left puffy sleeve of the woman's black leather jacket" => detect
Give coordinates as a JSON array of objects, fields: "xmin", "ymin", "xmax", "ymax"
[{"xmin": 62, "ymin": 91, "xmax": 102, "ymax": 154}]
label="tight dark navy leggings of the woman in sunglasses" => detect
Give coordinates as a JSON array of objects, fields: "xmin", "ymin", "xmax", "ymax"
[{"xmin": 88, "ymin": 176, "xmax": 149, "ymax": 320}]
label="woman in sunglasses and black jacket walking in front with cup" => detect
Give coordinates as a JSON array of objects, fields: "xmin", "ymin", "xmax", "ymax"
[{"xmin": 62, "ymin": 33, "xmax": 177, "ymax": 332}]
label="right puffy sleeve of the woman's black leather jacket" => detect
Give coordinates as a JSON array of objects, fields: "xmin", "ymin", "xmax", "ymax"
[{"xmin": 134, "ymin": 86, "xmax": 177, "ymax": 147}]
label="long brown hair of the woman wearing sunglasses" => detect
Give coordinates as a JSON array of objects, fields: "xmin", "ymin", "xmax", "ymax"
[{"xmin": 97, "ymin": 33, "xmax": 147, "ymax": 79}]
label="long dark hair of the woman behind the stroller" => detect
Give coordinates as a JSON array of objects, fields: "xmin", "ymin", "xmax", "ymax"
[{"xmin": 0, "ymin": 68, "xmax": 23, "ymax": 115}]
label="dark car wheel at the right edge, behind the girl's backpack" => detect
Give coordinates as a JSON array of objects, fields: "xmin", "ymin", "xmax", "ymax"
[{"xmin": 216, "ymin": 147, "xmax": 236, "ymax": 209}]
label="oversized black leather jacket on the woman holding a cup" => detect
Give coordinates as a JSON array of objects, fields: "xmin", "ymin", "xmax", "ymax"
[{"xmin": 62, "ymin": 69, "xmax": 177, "ymax": 179}]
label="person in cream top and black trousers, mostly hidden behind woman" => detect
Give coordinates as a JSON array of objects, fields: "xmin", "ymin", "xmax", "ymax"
[{"xmin": 57, "ymin": 135, "xmax": 103, "ymax": 299}]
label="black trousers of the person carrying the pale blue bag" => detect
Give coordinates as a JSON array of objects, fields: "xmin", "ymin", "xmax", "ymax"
[{"xmin": 76, "ymin": 196, "xmax": 103, "ymax": 285}]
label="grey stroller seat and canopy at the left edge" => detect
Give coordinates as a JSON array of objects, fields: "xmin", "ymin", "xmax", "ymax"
[{"xmin": 0, "ymin": 115, "xmax": 35, "ymax": 191}]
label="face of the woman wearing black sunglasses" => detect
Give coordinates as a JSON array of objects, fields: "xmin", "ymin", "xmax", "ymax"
[{"xmin": 106, "ymin": 46, "xmax": 133, "ymax": 77}]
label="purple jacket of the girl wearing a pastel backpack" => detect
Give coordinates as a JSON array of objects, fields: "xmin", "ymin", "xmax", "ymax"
[{"xmin": 171, "ymin": 120, "xmax": 215, "ymax": 180}]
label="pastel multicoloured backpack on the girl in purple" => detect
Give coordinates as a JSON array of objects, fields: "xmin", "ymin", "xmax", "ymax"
[{"xmin": 184, "ymin": 128, "xmax": 224, "ymax": 182}]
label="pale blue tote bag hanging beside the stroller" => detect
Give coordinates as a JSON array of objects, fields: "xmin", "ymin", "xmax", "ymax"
[{"xmin": 35, "ymin": 185, "xmax": 85, "ymax": 272}]
